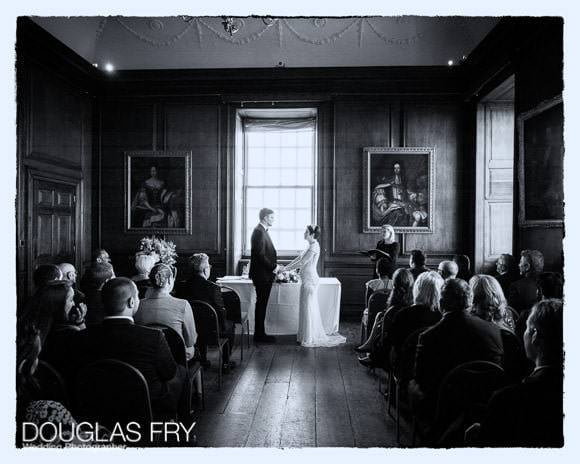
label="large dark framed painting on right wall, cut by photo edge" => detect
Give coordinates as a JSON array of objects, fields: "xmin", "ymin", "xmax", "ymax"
[{"xmin": 518, "ymin": 95, "xmax": 564, "ymax": 228}]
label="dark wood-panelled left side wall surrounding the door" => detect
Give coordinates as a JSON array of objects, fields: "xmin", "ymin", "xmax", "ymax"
[{"xmin": 16, "ymin": 54, "xmax": 93, "ymax": 303}]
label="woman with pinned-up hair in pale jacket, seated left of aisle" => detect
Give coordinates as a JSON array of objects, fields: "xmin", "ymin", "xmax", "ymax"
[{"xmin": 135, "ymin": 264, "xmax": 197, "ymax": 360}]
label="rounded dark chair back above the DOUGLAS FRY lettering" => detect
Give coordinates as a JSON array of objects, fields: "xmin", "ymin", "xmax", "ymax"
[{"xmin": 74, "ymin": 359, "xmax": 153, "ymax": 430}]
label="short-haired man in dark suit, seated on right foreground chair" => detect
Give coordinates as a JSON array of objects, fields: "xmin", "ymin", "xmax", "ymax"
[{"xmin": 410, "ymin": 279, "xmax": 504, "ymax": 415}]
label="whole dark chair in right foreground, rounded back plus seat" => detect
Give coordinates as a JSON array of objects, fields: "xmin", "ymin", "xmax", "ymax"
[{"xmin": 413, "ymin": 361, "xmax": 507, "ymax": 447}]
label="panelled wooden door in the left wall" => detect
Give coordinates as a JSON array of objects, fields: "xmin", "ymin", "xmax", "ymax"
[{"xmin": 28, "ymin": 178, "xmax": 77, "ymax": 288}]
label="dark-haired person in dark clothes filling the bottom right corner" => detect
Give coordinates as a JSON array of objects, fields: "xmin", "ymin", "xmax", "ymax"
[{"xmin": 472, "ymin": 299, "xmax": 564, "ymax": 447}]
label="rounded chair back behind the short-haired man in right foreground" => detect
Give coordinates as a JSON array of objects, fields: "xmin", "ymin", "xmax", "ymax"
[{"xmin": 434, "ymin": 361, "xmax": 507, "ymax": 445}]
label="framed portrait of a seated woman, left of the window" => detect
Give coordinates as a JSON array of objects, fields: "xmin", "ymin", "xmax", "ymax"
[{"xmin": 125, "ymin": 151, "xmax": 192, "ymax": 234}]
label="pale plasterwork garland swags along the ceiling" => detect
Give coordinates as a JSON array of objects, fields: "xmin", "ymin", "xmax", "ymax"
[{"xmin": 110, "ymin": 17, "xmax": 424, "ymax": 48}]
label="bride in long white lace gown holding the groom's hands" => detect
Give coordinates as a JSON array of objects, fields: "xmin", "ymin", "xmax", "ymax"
[{"xmin": 283, "ymin": 226, "xmax": 346, "ymax": 347}]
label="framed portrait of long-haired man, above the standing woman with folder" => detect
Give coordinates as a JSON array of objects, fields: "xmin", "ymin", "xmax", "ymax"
[{"xmin": 363, "ymin": 147, "xmax": 435, "ymax": 233}]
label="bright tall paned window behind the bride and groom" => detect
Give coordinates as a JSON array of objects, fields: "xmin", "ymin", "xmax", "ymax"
[{"xmin": 243, "ymin": 118, "xmax": 316, "ymax": 254}]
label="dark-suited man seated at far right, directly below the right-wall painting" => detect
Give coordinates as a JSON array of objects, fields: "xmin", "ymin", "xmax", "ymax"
[{"xmin": 508, "ymin": 250, "xmax": 544, "ymax": 314}]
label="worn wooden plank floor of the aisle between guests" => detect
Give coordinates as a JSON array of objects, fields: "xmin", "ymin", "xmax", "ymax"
[{"xmin": 196, "ymin": 323, "xmax": 397, "ymax": 448}]
